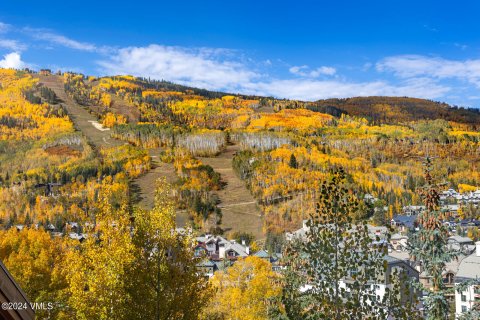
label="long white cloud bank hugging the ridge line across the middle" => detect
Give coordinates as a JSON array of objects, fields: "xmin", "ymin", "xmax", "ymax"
[{"xmin": 98, "ymin": 45, "xmax": 450, "ymax": 100}]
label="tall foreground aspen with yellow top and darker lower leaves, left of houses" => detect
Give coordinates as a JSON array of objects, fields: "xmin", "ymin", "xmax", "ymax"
[{"xmin": 127, "ymin": 179, "xmax": 211, "ymax": 320}]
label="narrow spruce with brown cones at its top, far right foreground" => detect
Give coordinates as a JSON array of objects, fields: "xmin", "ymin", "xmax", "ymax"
[{"xmin": 409, "ymin": 157, "xmax": 456, "ymax": 320}]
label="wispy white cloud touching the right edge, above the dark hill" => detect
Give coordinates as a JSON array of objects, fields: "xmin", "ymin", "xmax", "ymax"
[{"xmin": 376, "ymin": 55, "xmax": 480, "ymax": 87}]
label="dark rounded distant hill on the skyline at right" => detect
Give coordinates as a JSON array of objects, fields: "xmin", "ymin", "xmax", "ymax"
[{"xmin": 307, "ymin": 97, "xmax": 480, "ymax": 125}]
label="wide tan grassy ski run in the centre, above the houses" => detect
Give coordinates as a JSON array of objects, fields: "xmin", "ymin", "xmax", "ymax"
[{"xmin": 200, "ymin": 146, "xmax": 264, "ymax": 239}]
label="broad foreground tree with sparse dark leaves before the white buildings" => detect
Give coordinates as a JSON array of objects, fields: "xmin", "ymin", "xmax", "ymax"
[{"xmin": 277, "ymin": 169, "xmax": 418, "ymax": 320}]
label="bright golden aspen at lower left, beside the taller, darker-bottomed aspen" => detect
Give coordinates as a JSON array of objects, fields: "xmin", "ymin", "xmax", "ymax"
[{"xmin": 65, "ymin": 182, "xmax": 134, "ymax": 320}]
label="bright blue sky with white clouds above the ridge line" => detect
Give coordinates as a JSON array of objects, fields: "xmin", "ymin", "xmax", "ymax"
[{"xmin": 0, "ymin": 0, "xmax": 480, "ymax": 107}]
